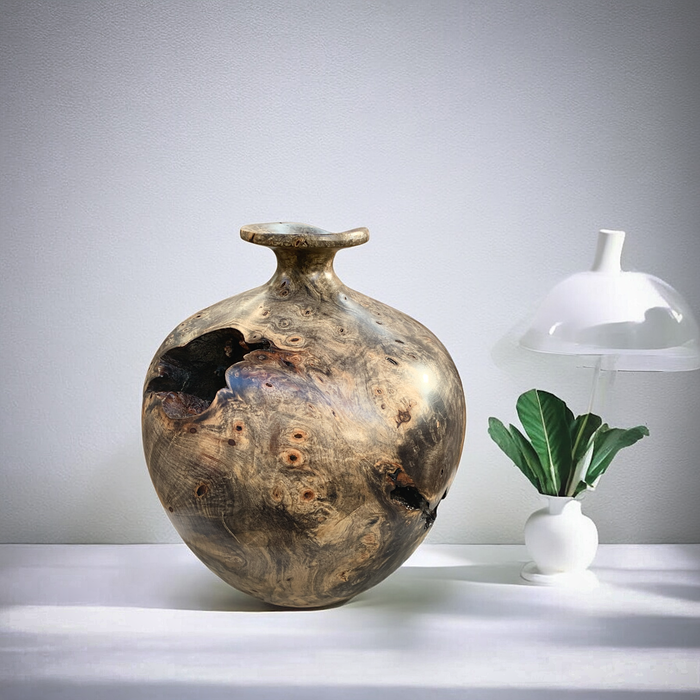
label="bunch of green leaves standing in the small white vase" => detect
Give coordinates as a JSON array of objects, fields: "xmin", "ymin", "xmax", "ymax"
[{"xmin": 489, "ymin": 389, "xmax": 649, "ymax": 497}]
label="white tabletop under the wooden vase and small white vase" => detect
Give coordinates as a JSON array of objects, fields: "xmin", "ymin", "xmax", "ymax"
[{"xmin": 0, "ymin": 545, "xmax": 700, "ymax": 700}]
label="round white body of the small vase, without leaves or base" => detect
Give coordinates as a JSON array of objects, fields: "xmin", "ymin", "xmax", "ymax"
[{"xmin": 525, "ymin": 496, "xmax": 598, "ymax": 575}]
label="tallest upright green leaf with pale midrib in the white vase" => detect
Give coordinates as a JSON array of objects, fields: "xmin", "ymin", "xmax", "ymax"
[{"xmin": 515, "ymin": 389, "xmax": 573, "ymax": 495}]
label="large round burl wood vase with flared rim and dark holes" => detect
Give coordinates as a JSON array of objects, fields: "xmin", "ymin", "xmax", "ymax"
[{"xmin": 143, "ymin": 224, "xmax": 466, "ymax": 607}]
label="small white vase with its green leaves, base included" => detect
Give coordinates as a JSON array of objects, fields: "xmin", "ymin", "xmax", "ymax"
[{"xmin": 489, "ymin": 389, "xmax": 649, "ymax": 585}]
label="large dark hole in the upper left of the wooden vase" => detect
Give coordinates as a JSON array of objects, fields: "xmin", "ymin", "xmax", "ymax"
[{"xmin": 147, "ymin": 328, "xmax": 270, "ymax": 418}]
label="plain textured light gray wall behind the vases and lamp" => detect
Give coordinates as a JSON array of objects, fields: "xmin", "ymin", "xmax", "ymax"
[{"xmin": 0, "ymin": 0, "xmax": 700, "ymax": 542}]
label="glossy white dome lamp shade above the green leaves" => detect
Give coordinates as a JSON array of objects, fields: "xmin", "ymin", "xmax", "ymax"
[{"xmin": 520, "ymin": 231, "xmax": 700, "ymax": 371}]
